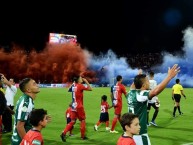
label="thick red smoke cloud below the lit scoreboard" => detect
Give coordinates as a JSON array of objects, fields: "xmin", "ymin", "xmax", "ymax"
[{"xmin": 0, "ymin": 43, "xmax": 97, "ymax": 83}]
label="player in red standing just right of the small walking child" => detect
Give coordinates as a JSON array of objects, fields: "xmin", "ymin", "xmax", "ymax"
[{"xmin": 110, "ymin": 75, "xmax": 127, "ymax": 133}]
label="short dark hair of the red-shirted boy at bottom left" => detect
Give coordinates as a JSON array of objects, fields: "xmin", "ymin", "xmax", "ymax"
[{"xmin": 29, "ymin": 109, "xmax": 47, "ymax": 126}]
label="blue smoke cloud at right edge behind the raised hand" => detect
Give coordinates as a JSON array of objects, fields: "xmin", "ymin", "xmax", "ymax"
[{"xmin": 152, "ymin": 27, "xmax": 193, "ymax": 87}]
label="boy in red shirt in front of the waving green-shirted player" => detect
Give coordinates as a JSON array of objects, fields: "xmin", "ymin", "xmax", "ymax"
[{"xmin": 117, "ymin": 113, "xmax": 141, "ymax": 145}]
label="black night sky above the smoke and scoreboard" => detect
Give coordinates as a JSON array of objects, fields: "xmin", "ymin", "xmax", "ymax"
[{"xmin": 0, "ymin": 0, "xmax": 193, "ymax": 55}]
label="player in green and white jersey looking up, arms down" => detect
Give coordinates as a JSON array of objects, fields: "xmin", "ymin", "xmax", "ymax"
[{"xmin": 11, "ymin": 78, "xmax": 40, "ymax": 145}]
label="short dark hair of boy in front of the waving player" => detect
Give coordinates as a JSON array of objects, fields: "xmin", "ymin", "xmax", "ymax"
[{"xmin": 120, "ymin": 113, "xmax": 138, "ymax": 131}]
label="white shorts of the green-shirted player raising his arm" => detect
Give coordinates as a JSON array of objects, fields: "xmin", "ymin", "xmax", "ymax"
[{"xmin": 133, "ymin": 134, "xmax": 151, "ymax": 145}]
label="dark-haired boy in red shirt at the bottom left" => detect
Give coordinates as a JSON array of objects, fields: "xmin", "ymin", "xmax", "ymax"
[{"xmin": 20, "ymin": 109, "xmax": 48, "ymax": 145}]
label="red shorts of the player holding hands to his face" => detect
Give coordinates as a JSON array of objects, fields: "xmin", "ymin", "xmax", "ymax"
[{"xmin": 71, "ymin": 107, "xmax": 86, "ymax": 121}]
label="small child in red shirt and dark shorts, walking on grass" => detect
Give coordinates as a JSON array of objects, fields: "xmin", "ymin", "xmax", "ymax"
[{"xmin": 94, "ymin": 95, "xmax": 113, "ymax": 131}]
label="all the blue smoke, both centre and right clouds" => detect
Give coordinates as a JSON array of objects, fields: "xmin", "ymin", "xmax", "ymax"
[{"xmin": 90, "ymin": 27, "xmax": 193, "ymax": 87}]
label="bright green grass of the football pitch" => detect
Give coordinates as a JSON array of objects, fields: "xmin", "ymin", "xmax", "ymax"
[{"xmin": 2, "ymin": 88, "xmax": 193, "ymax": 145}]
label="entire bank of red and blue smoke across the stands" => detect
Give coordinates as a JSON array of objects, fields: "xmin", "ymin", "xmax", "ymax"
[{"xmin": 0, "ymin": 27, "xmax": 193, "ymax": 87}]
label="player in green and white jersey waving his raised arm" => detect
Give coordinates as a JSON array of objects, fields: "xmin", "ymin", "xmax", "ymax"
[{"xmin": 127, "ymin": 64, "xmax": 180, "ymax": 145}]
